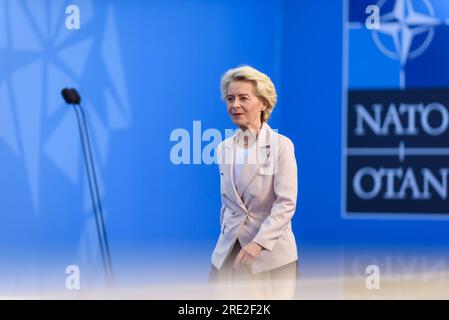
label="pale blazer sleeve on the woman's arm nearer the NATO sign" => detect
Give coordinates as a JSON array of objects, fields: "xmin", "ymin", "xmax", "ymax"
[{"xmin": 253, "ymin": 138, "xmax": 298, "ymax": 251}]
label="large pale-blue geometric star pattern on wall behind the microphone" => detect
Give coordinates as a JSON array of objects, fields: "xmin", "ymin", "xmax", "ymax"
[{"xmin": 0, "ymin": 0, "xmax": 131, "ymax": 214}]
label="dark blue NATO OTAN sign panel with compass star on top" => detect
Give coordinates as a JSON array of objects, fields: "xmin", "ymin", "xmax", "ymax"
[{"xmin": 342, "ymin": 0, "xmax": 449, "ymax": 217}]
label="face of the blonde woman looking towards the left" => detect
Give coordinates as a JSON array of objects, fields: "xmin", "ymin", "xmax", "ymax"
[{"xmin": 226, "ymin": 81, "xmax": 266, "ymax": 130}]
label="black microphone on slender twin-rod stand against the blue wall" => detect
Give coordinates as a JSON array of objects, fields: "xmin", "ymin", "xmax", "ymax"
[{"xmin": 61, "ymin": 88, "xmax": 115, "ymax": 286}]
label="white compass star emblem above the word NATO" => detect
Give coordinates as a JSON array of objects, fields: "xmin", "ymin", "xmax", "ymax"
[{"xmin": 372, "ymin": 0, "xmax": 445, "ymax": 88}]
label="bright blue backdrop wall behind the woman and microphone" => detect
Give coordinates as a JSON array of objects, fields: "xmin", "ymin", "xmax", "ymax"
[{"xmin": 0, "ymin": 0, "xmax": 449, "ymax": 291}]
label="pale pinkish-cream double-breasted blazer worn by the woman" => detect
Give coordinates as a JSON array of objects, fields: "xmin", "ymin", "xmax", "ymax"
[{"xmin": 212, "ymin": 123, "xmax": 298, "ymax": 273}]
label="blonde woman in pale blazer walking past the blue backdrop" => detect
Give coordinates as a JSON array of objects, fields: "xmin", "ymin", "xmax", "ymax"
[{"xmin": 210, "ymin": 66, "xmax": 298, "ymax": 299}]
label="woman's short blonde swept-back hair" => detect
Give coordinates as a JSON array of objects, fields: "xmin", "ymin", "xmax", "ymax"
[{"xmin": 220, "ymin": 66, "xmax": 277, "ymax": 122}]
